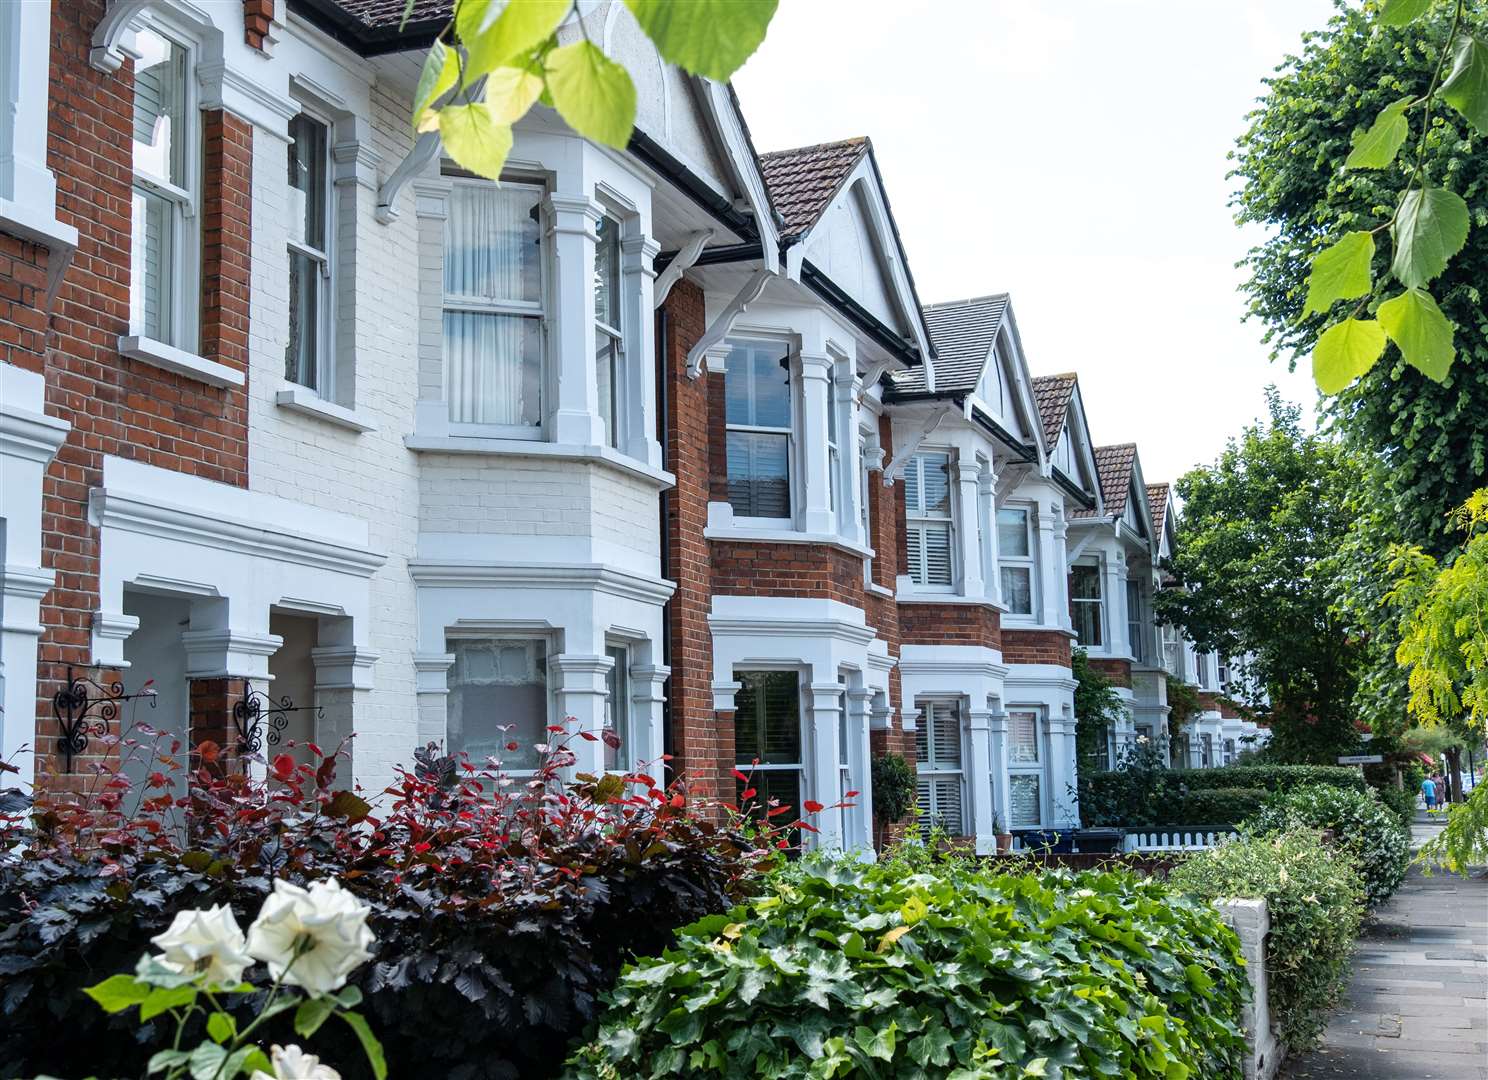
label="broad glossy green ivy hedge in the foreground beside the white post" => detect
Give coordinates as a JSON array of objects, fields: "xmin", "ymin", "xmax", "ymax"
[{"xmin": 570, "ymin": 861, "xmax": 1248, "ymax": 1079}]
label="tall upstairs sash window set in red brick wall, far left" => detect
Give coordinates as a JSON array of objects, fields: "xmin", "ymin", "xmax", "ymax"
[{"xmin": 129, "ymin": 28, "xmax": 199, "ymax": 353}]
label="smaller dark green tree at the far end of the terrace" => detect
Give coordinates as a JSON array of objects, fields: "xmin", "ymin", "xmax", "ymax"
[{"xmin": 1158, "ymin": 387, "xmax": 1362, "ymax": 762}]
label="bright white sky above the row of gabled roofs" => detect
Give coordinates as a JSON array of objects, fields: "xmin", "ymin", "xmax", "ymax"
[{"xmin": 734, "ymin": 0, "xmax": 1333, "ymax": 482}]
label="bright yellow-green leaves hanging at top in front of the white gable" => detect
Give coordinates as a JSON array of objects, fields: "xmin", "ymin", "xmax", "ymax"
[{"xmin": 403, "ymin": 0, "xmax": 777, "ymax": 180}]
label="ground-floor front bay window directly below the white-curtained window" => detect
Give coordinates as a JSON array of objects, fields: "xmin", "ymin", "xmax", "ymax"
[{"xmin": 446, "ymin": 637, "xmax": 548, "ymax": 772}]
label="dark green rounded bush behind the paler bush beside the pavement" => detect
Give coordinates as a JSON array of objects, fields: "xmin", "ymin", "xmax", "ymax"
[{"xmin": 1245, "ymin": 787, "xmax": 1411, "ymax": 906}]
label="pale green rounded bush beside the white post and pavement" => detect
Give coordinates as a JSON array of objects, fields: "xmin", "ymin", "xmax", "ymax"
[{"xmin": 1168, "ymin": 829, "xmax": 1364, "ymax": 1053}]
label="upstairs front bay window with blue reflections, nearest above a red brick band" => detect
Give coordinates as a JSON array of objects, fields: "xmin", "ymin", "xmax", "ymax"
[{"xmin": 723, "ymin": 342, "xmax": 792, "ymax": 519}]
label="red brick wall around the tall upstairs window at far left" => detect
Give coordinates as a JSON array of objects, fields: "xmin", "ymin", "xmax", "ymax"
[{"xmin": 28, "ymin": 0, "xmax": 251, "ymax": 771}]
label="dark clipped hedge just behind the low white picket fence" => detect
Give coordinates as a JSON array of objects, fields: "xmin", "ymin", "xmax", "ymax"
[{"xmin": 1079, "ymin": 754, "xmax": 1364, "ymax": 829}]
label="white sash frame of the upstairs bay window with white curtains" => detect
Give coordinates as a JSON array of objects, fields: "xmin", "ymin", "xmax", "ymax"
[{"xmin": 439, "ymin": 173, "xmax": 550, "ymax": 439}]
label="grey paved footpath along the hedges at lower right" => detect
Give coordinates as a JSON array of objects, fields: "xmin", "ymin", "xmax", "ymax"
[{"xmin": 1280, "ymin": 811, "xmax": 1488, "ymax": 1080}]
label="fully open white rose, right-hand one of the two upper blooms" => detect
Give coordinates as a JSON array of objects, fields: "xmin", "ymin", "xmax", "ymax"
[{"xmin": 248, "ymin": 879, "xmax": 373, "ymax": 994}]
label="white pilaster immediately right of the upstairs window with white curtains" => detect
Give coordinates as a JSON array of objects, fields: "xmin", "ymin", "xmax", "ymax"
[{"xmin": 545, "ymin": 192, "xmax": 604, "ymax": 446}]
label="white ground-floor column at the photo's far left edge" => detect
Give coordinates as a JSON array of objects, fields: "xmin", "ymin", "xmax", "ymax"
[{"xmin": 0, "ymin": 367, "xmax": 70, "ymax": 787}]
